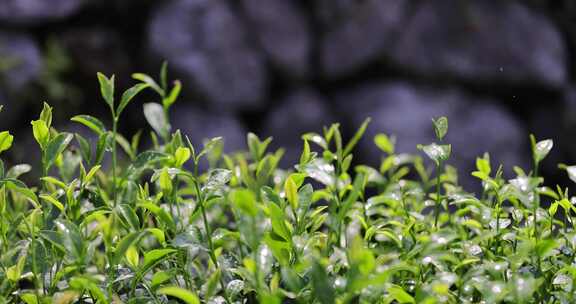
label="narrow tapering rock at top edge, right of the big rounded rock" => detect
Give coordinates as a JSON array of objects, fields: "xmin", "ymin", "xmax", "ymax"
[{"xmin": 242, "ymin": 0, "xmax": 311, "ymax": 76}]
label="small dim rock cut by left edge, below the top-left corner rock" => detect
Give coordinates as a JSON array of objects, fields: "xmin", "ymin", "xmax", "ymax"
[{"xmin": 0, "ymin": 32, "xmax": 42, "ymax": 93}]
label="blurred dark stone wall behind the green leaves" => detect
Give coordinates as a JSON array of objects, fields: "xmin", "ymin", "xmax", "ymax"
[{"xmin": 0, "ymin": 0, "xmax": 576, "ymax": 189}]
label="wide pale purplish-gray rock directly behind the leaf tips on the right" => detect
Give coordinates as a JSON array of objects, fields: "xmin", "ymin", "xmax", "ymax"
[{"xmin": 337, "ymin": 82, "xmax": 529, "ymax": 189}]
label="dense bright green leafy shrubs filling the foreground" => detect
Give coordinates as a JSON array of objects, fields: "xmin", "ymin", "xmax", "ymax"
[{"xmin": 0, "ymin": 67, "xmax": 576, "ymax": 304}]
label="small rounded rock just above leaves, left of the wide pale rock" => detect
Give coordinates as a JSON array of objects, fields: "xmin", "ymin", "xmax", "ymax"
[{"xmin": 262, "ymin": 89, "xmax": 336, "ymax": 166}]
